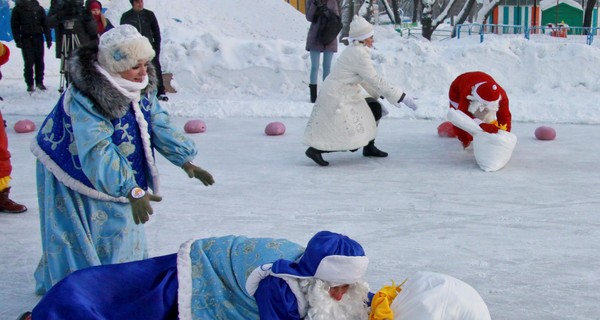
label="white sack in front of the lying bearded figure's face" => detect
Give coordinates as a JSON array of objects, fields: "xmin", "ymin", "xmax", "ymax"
[{"xmin": 391, "ymin": 272, "xmax": 491, "ymax": 320}]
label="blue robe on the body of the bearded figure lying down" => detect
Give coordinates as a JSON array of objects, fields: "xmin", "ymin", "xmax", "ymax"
[{"xmin": 32, "ymin": 236, "xmax": 304, "ymax": 320}]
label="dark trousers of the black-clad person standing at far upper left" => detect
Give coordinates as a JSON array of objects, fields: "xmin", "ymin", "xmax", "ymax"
[{"xmin": 21, "ymin": 34, "xmax": 45, "ymax": 86}]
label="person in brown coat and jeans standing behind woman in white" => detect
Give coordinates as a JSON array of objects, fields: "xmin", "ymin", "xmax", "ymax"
[{"xmin": 306, "ymin": 0, "xmax": 340, "ymax": 103}]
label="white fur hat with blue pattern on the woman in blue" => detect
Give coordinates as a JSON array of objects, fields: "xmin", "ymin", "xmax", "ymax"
[{"xmin": 98, "ymin": 24, "xmax": 155, "ymax": 73}]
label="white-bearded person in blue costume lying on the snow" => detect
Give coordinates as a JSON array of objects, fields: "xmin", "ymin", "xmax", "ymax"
[{"xmin": 31, "ymin": 231, "xmax": 372, "ymax": 320}]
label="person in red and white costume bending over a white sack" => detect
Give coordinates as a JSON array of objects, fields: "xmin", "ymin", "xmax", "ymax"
[{"xmin": 448, "ymin": 71, "xmax": 511, "ymax": 149}]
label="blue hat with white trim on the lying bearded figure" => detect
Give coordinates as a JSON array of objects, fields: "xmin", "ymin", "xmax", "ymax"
[{"xmin": 271, "ymin": 231, "xmax": 369, "ymax": 285}]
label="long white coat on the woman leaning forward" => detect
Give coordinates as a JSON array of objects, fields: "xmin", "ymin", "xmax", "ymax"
[{"xmin": 302, "ymin": 41, "xmax": 404, "ymax": 151}]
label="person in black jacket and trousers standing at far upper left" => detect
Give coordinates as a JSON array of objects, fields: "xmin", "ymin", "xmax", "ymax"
[{"xmin": 10, "ymin": 0, "xmax": 52, "ymax": 92}]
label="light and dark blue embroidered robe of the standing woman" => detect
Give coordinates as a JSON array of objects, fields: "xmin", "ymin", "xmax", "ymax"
[{"xmin": 31, "ymin": 87, "xmax": 197, "ymax": 294}]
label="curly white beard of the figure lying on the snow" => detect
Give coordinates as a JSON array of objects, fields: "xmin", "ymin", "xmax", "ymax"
[{"xmin": 300, "ymin": 279, "xmax": 369, "ymax": 320}]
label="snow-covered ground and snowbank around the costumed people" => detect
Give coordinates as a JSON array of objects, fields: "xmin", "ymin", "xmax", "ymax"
[{"xmin": 0, "ymin": 0, "xmax": 600, "ymax": 320}]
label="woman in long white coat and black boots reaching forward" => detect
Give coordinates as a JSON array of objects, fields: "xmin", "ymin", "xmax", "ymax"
[{"xmin": 303, "ymin": 16, "xmax": 417, "ymax": 166}]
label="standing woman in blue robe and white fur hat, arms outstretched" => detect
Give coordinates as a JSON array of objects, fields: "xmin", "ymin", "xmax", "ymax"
[{"xmin": 31, "ymin": 26, "xmax": 214, "ymax": 294}]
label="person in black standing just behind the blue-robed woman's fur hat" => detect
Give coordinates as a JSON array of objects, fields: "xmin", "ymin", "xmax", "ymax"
[{"xmin": 121, "ymin": 0, "xmax": 169, "ymax": 101}]
